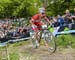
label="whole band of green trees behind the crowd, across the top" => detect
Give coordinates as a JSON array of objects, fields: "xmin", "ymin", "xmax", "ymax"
[{"xmin": 0, "ymin": 0, "xmax": 75, "ymax": 18}]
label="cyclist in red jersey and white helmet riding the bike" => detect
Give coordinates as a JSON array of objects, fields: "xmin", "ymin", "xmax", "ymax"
[{"xmin": 30, "ymin": 7, "xmax": 50, "ymax": 48}]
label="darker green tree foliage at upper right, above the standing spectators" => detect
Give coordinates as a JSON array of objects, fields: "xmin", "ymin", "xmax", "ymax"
[{"xmin": 47, "ymin": 0, "xmax": 75, "ymax": 15}]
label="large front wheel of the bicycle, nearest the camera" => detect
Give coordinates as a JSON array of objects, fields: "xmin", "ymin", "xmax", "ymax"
[{"xmin": 44, "ymin": 30, "xmax": 56, "ymax": 53}]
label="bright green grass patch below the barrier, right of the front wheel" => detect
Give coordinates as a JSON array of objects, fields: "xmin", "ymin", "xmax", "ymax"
[{"xmin": 56, "ymin": 34, "xmax": 75, "ymax": 48}]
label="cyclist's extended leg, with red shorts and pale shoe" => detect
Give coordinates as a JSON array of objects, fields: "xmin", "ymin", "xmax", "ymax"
[{"xmin": 32, "ymin": 22, "xmax": 42, "ymax": 46}]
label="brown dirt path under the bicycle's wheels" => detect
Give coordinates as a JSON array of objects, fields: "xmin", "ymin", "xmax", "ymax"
[{"xmin": 18, "ymin": 45, "xmax": 75, "ymax": 60}]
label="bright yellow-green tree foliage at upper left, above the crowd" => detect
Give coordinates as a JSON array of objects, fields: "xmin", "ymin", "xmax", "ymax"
[{"xmin": 0, "ymin": 0, "xmax": 41, "ymax": 17}]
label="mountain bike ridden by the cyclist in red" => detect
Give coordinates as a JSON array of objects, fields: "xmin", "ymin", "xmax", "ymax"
[{"xmin": 30, "ymin": 24, "xmax": 56, "ymax": 53}]
